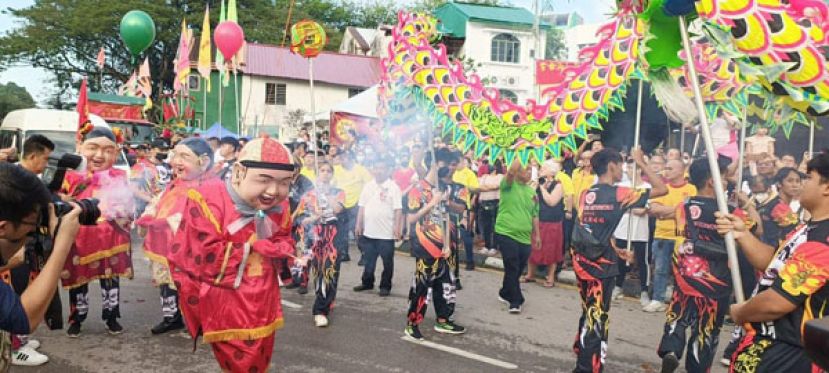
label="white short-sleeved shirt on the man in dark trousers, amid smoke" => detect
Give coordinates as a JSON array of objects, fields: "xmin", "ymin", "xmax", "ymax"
[{"xmin": 357, "ymin": 179, "xmax": 403, "ymax": 240}]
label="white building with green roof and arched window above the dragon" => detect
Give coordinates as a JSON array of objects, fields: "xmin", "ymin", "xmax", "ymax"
[{"xmin": 434, "ymin": 2, "xmax": 550, "ymax": 103}]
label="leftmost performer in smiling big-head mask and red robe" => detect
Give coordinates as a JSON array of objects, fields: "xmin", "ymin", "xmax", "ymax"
[{"xmin": 61, "ymin": 127, "xmax": 134, "ymax": 337}]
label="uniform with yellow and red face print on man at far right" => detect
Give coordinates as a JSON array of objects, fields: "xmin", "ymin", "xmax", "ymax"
[{"xmin": 731, "ymin": 220, "xmax": 829, "ymax": 373}]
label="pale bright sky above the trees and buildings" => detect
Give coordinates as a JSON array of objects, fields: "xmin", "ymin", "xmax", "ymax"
[{"xmin": 0, "ymin": 0, "xmax": 615, "ymax": 102}]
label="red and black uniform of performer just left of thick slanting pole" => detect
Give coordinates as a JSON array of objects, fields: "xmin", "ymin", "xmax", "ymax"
[{"xmin": 657, "ymin": 197, "xmax": 745, "ymax": 373}]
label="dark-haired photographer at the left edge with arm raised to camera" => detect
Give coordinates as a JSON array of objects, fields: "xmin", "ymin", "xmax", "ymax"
[{"xmin": 0, "ymin": 163, "xmax": 80, "ymax": 371}]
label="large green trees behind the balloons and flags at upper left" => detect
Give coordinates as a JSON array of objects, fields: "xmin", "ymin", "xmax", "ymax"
[{"xmin": 0, "ymin": 0, "xmax": 376, "ymax": 119}]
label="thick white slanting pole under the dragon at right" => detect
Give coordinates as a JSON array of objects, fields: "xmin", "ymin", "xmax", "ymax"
[{"xmin": 679, "ymin": 16, "xmax": 745, "ymax": 303}]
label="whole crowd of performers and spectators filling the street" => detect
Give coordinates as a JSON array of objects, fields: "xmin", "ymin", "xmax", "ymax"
[{"xmin": 0, "ymin": 117, "xmax": 829, "ymax": 372}]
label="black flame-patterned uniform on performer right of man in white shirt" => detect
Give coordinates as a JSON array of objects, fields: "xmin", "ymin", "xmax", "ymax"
[{"xmin": 403, "ymin": 180, "xmax": 456, "ymax": 326}]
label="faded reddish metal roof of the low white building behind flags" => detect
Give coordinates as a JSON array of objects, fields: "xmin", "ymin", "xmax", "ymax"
[{"xmin": 242, "ymin": 43, "xmax": 381, "ymax": 88}]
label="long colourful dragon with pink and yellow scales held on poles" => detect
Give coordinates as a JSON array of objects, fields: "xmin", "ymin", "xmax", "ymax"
[{"xmin": 378, "ymin": 0, "xmax": 829, "ymax": 163}]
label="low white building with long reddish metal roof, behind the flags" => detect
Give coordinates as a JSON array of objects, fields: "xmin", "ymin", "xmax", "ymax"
[{"xmin": 240, "ymin": 43, "xmax": 380, "ymax": 139}]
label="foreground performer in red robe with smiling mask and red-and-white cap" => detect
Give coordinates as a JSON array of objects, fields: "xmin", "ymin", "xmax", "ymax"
[{"xmin": 167, "ymin": 138, "xmax": 295, "ymax": 372}]
